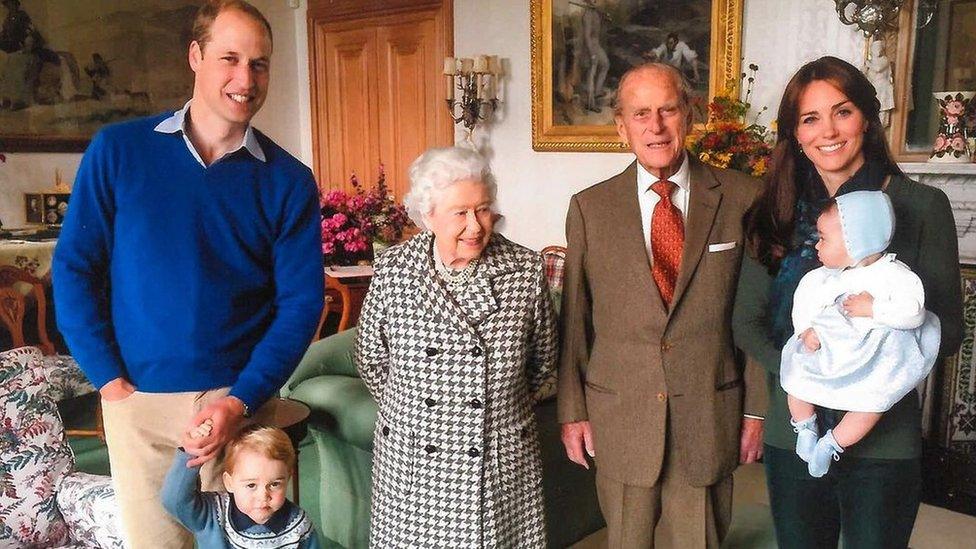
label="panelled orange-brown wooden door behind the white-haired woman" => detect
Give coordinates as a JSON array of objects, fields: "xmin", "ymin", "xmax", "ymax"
[{"xmin": 309, "ymin": 0, "xmax": 454, "ymax": 200}]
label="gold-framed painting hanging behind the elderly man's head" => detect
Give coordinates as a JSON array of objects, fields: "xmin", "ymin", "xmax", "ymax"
[{"xmin": 531, "ymin": 0, "xmax": 742, "ymax": 152}]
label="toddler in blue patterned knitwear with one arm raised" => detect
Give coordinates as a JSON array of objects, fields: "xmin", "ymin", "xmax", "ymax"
[{"xmin": 162, "ymin": 419, "xmax": 319, "ymax": 549}]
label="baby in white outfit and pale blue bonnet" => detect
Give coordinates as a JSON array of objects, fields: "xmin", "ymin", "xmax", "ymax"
[{"xmin": 780, "ymin": 191, "xmax": 940, "ymax": 477}]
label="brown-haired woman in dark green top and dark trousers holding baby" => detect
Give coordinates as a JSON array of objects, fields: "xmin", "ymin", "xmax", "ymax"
[{"xmin": 733, "ymin": 57, "xmax": 962, "ymax": 549}]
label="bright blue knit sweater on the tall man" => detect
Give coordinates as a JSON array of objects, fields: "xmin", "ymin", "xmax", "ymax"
[{"xmin": 52, "ymin": 113, "xmax": 323, "ymax": 410}]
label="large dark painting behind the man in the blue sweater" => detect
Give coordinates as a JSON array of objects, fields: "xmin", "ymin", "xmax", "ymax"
[{"xmin": 0, "ymin": 0, "xmax": 200, "ymax": 152}]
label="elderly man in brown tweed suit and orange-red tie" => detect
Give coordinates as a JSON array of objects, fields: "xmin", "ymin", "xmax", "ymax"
[{"xmin": 558, "ymin": 63, "xmax": 763, "ymax": 549}]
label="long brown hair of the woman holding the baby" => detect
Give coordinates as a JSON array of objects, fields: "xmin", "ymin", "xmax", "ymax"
[{"xmin": 744, "ymin": 56, "xmax": 902, "ymax": 273}]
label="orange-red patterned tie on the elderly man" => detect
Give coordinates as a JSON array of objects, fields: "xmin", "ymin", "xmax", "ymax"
[{"xmin": 651, "ymin": 179, "xmax": 685, "ymax": 307}]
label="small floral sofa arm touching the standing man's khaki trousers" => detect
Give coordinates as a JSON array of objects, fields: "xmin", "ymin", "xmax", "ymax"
[{"xmin": 58, "ymin": 473, "xmax": 124, "ymax": 549}]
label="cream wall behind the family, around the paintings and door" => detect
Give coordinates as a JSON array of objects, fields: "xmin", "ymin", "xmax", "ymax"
[{"xmin": 0, "ymin": 0, "xmax": 863, "ymax": 249}]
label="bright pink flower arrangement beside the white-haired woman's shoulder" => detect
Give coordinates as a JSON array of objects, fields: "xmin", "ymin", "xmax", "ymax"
[{"xmin": 320, "ymin": 166, "xmax": 410, "ymax": 265}]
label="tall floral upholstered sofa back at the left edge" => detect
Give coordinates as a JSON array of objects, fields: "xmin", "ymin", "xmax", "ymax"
[{"xmin": 0, "ymin": 347, "xmax": 74, "ymax": 547}]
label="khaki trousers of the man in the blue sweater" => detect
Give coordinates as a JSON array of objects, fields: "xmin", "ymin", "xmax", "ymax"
[{"xmin": 102, "ymin": 387, "xmax": 275, "ymax": 549}]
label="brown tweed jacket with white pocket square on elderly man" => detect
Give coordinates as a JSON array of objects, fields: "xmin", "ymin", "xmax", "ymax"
[{"xmin": 558, "ymin": 158, "xmax": 764, "ymax": 486}]
